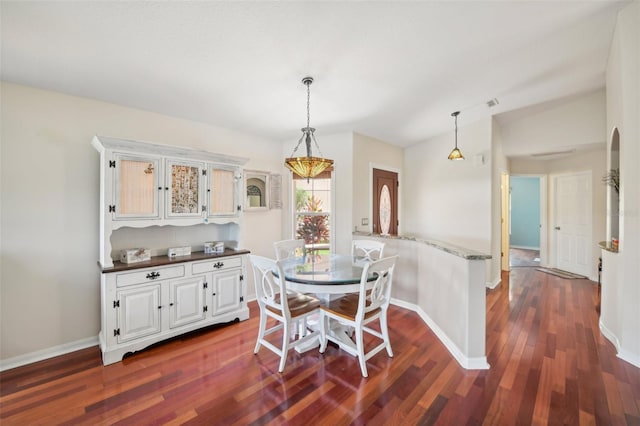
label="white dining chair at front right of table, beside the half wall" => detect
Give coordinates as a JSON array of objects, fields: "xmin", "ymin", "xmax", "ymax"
[{"xmin": 320, "ymin": 255, "xmax": 398, "ymax": 377}]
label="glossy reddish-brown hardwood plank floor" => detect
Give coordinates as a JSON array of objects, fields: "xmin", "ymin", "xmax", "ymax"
[{"xmin": 0, "ymin": 268, "xmax": 640, "ymax": 426}]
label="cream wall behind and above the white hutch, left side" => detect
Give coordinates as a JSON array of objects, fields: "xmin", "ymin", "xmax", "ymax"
[{"xmin": 0, "ymin": 82, "xmax": 284, "ymax": 360}]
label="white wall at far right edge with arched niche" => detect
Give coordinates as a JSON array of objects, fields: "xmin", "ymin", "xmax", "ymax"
[{"xmin": 600, "ymin": 1, "xmax": 640, "ymax": 367}]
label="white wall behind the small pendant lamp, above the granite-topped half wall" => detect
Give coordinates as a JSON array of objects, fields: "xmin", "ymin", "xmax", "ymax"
[{"xmin": 400, "ymin": 115, "xmax": 499, "ymax": 281}]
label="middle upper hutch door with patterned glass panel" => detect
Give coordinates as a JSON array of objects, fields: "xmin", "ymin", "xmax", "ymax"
[{"xmin": 164, "ymin": 160, "xmax": 206, "ymax": 219}]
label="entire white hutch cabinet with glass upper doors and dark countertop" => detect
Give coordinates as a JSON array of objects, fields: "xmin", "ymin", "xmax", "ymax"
[{"xmin": 92, "ymin": 136, "xmax": 249, "ymax": 365}]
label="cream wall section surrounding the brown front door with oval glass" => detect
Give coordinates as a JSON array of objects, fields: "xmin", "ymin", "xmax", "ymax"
[{"xmin": 351, "ymin": 133, "xmax": 405, "ymax": 234}]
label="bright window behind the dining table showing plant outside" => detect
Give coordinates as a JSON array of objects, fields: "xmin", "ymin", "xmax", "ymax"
[{"xmin": 293, "ymin": 170, "xmax": 332, "ymax": 253}]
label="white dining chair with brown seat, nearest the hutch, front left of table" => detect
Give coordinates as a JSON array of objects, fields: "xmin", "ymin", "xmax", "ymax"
[{"xmin": 249, "ymin": 255, "xmax": 320, "ymax": 373}]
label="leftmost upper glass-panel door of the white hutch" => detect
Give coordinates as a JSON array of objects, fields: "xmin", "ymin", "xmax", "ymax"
[{"xmin": 114, "ymin": 154, "xmax": 162, "ymax": 220}]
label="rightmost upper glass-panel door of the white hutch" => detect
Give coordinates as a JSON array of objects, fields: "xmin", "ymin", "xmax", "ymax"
[{"xmin": 207, "ymin": 164, "xmax": 240, "ymax": 217}]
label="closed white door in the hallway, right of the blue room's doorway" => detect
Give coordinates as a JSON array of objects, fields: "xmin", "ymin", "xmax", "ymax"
[{"xmin": 554, "ymin": 172, "xmax": 592, "ymax": 276}]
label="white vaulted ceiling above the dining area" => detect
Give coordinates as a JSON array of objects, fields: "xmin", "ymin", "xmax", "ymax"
[{"xmin": 0, "ymin": 0, "xmax": 628, "ymax": 147}]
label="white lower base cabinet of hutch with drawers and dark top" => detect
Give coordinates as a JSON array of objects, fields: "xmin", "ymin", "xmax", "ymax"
[{"xmin": 100, "ymin": 250, "xmax": 249, "ymax": 365}]
